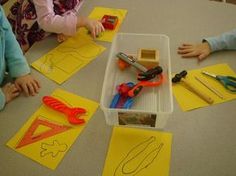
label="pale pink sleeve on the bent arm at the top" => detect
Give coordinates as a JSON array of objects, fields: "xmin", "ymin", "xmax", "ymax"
[{"xmin": 33, "ymin": 0, "xmax": 77, "ymax": 36}]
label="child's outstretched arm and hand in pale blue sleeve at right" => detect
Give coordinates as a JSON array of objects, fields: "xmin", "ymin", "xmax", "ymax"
[{"xmin": 178, "ymin": 29, "xmax": 236, "ymax": 61}]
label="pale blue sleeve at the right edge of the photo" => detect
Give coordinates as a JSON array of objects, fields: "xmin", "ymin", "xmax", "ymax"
[{"xmin": 204, "ymin": 29, "xmax": 236, "ymax": 52}]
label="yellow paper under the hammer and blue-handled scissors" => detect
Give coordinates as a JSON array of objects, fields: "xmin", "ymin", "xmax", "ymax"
[{"xmin": 173, "ymin": 64, "xmax": 236, "ymax": 111}]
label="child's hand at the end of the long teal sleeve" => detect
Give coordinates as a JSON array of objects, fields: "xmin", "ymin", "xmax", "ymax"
[{"xmin": 15, "ymin": 74, "xmax": 40, "ymax": 96}]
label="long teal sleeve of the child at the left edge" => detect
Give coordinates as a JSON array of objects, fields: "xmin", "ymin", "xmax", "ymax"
[{"xmin": 1, "ymin": 7, "xmax": 30, "ymax": 78}]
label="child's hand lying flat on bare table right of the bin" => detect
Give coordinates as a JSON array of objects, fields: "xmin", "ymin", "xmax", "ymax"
[{"xmin": 178, "ymin": 42, "xmax": 211, "ymax": 61}]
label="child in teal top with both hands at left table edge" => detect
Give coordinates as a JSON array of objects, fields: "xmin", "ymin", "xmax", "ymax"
[{"xmin": 0, "ymin": 6, "xmax": 40, "ymax": 110}]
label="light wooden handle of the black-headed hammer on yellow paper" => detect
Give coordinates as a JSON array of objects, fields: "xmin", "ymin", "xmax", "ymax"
[{"xmin": 181, "ymin": 78, "xmax": 214, "ymax": 104}]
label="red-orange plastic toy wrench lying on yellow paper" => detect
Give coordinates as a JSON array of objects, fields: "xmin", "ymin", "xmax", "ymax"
[{"xmin": 43, "ymin": 96, "xmax": 87, "ymax": 124}]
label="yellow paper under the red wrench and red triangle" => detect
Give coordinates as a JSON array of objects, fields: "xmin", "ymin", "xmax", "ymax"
[{"xmin": 6, "ymin": 89, "xmax": 98, "ymax": 169}]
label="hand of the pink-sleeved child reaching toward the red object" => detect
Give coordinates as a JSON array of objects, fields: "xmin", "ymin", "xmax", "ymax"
[{"xmin": 85, "ymin": 18, "xmax": 105, "ymax": 38}]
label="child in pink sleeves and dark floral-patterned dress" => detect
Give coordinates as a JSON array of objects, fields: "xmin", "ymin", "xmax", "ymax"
[{"xmin": 8, "ymin": 0, "xmax": 104, "ymax": 52}]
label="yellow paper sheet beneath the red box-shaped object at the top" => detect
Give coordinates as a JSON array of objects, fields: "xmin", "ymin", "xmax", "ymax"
[{"xmin": 79, "ymin": 7, "xmax": 127, "ymax": 42}]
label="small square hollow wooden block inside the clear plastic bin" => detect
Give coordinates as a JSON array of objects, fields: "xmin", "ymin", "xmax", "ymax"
[{"xmin": 137, "ymin": 48, "xmax": 159, "ymax": 68}]
